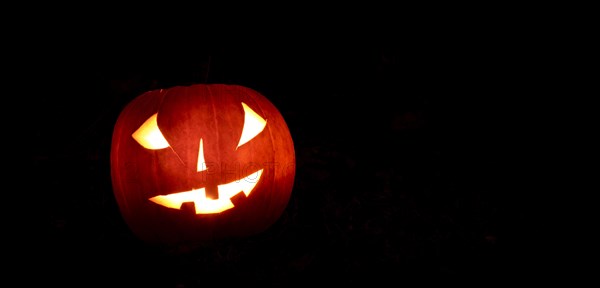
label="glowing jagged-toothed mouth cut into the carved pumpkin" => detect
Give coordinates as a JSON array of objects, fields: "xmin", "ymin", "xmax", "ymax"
[{"xmin": 149, "ymin": 169, "xmax": 263, "ymax": 214}]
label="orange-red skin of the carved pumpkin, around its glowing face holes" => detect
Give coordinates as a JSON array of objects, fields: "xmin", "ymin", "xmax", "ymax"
[{"xmin": 110, "ymin": 84, "xmax": 295, "ymax": 244}]
